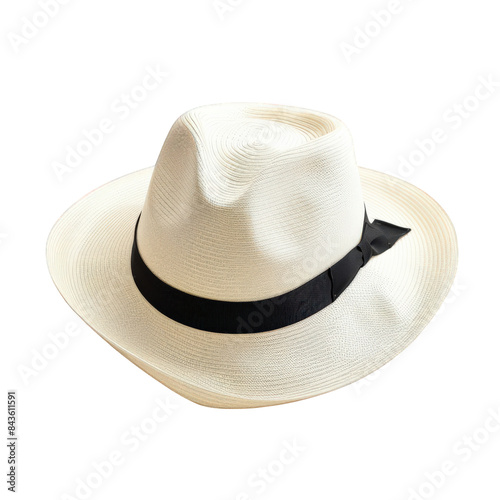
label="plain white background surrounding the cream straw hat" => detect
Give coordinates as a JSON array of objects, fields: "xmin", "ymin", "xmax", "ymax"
[{"xmin": 0, "ymin": 0, "xmax": 500, "ymax": 500}]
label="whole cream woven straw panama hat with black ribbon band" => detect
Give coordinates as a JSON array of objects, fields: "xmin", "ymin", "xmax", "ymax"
[{"xmin": 47, "ymin": 103, "xmax": 457, "ymax": 408}]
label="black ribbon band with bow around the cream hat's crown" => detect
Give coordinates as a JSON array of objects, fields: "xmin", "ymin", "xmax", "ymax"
[{"xmin": 132, "ymin": 212, "xmax": 410, "ymax": 333}]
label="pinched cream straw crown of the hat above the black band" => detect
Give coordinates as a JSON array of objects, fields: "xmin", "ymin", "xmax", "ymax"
[{"xmin": 137, "ymin": 103, "xmax": 364, "ymax": 301}]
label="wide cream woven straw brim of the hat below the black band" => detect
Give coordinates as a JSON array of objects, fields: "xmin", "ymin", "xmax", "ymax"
[{"xmin": 47, "ymin": 168, "xmax": 458, "ymax": 408}]
